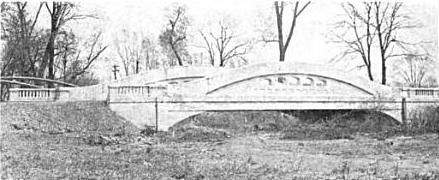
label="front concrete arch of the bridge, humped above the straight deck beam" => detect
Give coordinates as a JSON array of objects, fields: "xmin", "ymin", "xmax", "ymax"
[{"xmin": 184, "ymin": 62, "xmax": 399, "ymax": 97}]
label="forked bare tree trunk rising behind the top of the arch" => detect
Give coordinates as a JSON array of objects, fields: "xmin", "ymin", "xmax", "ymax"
[{"xmin": 271, "ymin": 1, "xmax": 311, "ymax": 62}]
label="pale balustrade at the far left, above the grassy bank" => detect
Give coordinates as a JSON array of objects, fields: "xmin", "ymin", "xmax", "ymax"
[{"xmin": 9, "ymin": 88, "xmax": 69, "ymax": 101}]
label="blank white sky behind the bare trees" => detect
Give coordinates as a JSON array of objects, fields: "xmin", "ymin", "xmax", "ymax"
[{"xmin": 9, "ymin": 0, "xmax": 439, "ymax": 84}]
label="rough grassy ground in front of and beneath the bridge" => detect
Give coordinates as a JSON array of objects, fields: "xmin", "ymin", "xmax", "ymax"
[{"xmin": 0, "ymin": 102, "xmax": 439, "ymax": 179}]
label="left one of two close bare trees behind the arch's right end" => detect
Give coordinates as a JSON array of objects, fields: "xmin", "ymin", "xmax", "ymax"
[{"xmin": 334, "ymin": 2, "xmax": 376, "ymax": 81}]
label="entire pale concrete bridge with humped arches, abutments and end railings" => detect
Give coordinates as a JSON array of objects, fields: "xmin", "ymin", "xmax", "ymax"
[{"xmin": 6, "ymin": 62, "xmax": 439, "ymax": 130}]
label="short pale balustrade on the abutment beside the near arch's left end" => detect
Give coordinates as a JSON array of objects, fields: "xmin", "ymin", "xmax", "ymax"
[{"xmin": 107, "ymin": 86, "xmax": 166, "ymax": 102}]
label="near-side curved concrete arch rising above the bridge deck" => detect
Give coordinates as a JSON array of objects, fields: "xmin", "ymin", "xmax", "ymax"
[{"xmin": 179, "ymin": 62, "xmax": 399, "ymax": 97}]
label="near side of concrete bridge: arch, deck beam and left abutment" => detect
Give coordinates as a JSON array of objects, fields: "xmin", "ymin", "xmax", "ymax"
[{"xmin": 109, "ymin": 62, "xmax": 410, "ymax": 130}]
